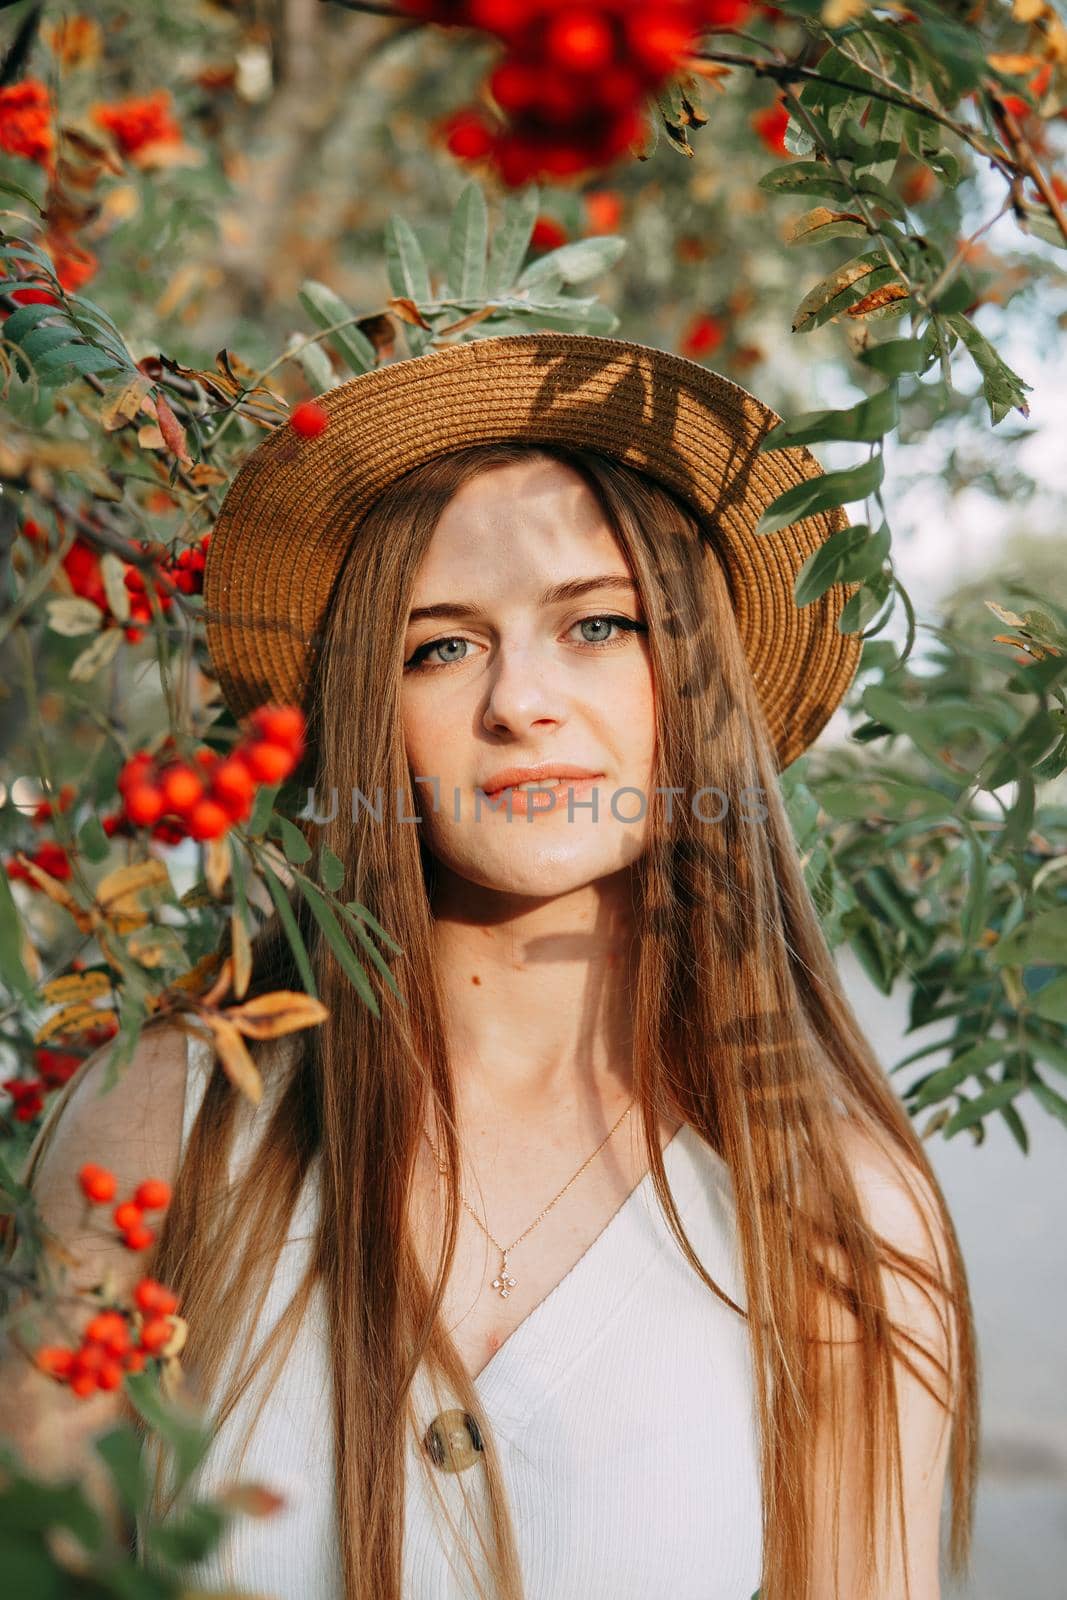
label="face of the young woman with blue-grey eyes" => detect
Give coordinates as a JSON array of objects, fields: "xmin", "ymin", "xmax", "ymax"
[{"xmin": 402, "ymin": 459, "xmax": 654, "ymax": 896}]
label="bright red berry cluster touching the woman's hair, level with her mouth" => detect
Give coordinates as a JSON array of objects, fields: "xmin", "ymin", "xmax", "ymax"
[{"xmin": 118, "ymin": 706, "xmax": 306, "ymax": 843}]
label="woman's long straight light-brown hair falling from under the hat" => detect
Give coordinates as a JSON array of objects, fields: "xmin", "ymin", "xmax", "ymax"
[{"xmin": 20, "ymin": 443, "xmax": 977, "ymax": 1600}]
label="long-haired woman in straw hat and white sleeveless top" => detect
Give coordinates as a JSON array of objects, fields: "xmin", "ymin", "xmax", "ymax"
[{"xmin": 8, "ymin": 334, "xmax": 976, "ymax": 1600}]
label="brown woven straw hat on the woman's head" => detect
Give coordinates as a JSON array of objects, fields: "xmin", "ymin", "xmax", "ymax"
[{"xmin": 205, "ymin": 333, "xmax": 861, "ymax": 766}]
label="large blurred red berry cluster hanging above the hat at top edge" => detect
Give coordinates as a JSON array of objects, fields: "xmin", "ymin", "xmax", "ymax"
[{"xmin": 402, "ymin": 0, "xmax": 753, "ymax": 187}]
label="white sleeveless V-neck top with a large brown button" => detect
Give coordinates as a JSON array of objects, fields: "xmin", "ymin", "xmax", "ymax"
[{"xmin": 158, "ymin": 1042, "xmax": 761, "ymax": 1600}]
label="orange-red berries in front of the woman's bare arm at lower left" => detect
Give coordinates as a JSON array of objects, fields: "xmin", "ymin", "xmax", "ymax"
[{"xmin": 34, "ymin": 1162, "xmax": 179, "ymax": 1400}]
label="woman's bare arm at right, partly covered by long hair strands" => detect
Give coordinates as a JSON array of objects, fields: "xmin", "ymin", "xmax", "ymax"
[{"xmin": 811, "ymin": 1136, "xmax": 952, "ymax": 1600}]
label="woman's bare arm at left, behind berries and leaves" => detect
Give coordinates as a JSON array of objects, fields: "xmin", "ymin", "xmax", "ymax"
[{"xmin": 0, "ymin": 1029, "xmax": 186, "ymax": 1533}]
